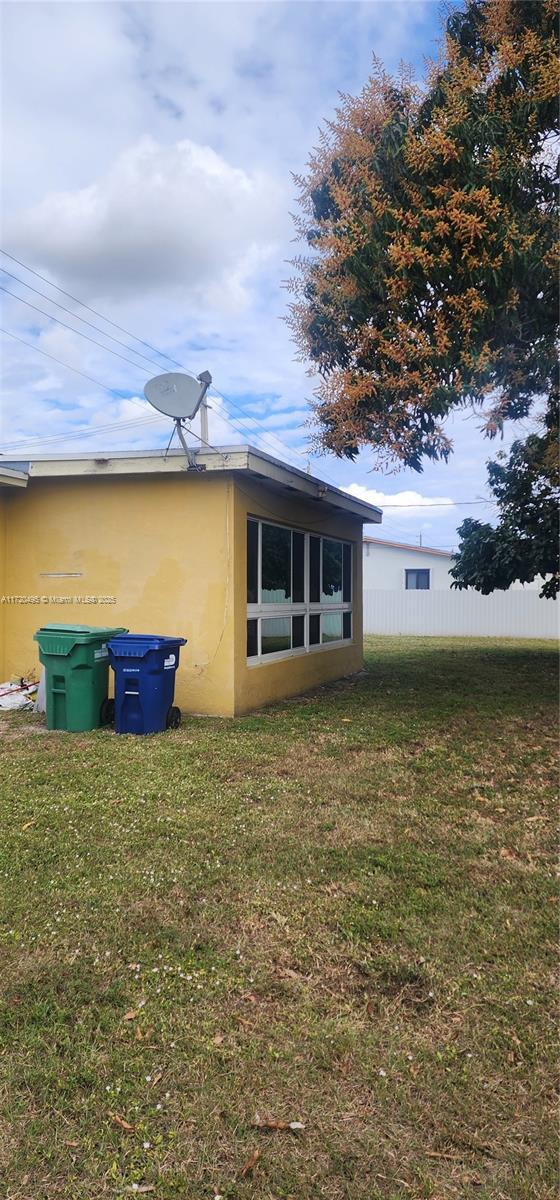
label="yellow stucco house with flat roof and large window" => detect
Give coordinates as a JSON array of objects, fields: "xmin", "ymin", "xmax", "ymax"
[{"xmin": 0, "ymin": 446, "xmax": 381, "ymax": 715}]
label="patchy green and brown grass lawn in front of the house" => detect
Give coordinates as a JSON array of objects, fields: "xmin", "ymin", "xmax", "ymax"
[{"xmin": 0, "ymin": 638, "xmax": 558, "ymax": 1200}]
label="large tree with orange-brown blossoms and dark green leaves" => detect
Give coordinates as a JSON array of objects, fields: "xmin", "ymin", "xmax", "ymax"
[{"xmin": 290, "ymin": 0, "xmax": 559, "ymax": 594}]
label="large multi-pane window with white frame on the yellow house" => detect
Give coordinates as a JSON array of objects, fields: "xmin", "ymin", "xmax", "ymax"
[{"xmin": 247, "ymin": 517, "xmax": 353, "ymax": 662}]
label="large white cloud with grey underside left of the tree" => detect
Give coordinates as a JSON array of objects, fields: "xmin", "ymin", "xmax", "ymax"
[{"xmin": 6, "ymin": 137, "xmax": 289, "ymax": 312}]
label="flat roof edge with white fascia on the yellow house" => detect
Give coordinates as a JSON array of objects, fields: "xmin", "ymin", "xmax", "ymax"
[{"xmin": 0, "ymin": 445, "xmax": 383, "ymax": 524}]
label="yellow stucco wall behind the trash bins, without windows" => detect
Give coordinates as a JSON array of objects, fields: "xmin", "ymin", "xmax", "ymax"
[{"xmin": 4, "ymin": 473, "xmax": 234, "ymax": 715}]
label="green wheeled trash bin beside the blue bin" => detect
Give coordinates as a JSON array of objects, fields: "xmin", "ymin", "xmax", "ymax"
[{"xmin": 34, "ymin": 624, "xmax": 127, "ymax": 733}]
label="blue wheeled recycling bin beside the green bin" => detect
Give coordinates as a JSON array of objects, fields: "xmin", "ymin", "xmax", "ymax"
[{"xmin": 107, "ymin": 634, "xmax": 186, "ymax": 733}]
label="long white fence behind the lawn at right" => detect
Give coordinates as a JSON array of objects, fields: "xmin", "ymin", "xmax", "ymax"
[{"xmin": 363, "ymin": 589, "xmax": 559, "ymax": 638}]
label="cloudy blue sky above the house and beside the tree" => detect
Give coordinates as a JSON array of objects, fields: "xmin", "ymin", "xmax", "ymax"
[{"xmin": 0, "ymin": 0, "xmax": 518, "ymax": 547}]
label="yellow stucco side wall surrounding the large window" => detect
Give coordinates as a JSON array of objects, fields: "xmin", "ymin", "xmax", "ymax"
[{"xmin": 234, "ymin": 479, "xmax": 363, "ymax": 714}]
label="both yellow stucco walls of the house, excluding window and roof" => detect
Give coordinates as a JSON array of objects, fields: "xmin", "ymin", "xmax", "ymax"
[{"xmin": 0, "ymin": 472, "xmax": 362, "ymax": 716}]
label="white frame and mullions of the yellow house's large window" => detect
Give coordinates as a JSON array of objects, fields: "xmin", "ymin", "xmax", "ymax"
[{"xmin": 245, "ymin": 514, "xmax": 356, "ymax": 666}]
